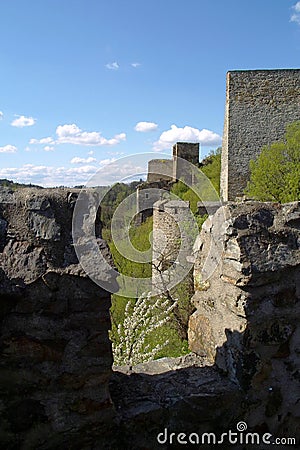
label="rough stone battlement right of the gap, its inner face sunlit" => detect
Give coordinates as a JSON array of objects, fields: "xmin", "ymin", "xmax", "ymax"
[{"xmin": 189, "ymin": 202, "xmax": 300, "ymax": 438}]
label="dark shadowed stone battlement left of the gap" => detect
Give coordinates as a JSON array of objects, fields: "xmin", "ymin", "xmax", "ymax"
[{"xmin": 0, "ymin": 189, "xmax": 114, "ymax": 450}]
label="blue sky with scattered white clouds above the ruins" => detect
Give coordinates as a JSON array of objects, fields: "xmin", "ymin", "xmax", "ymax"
[{"xmin": 0, "ymin": 0, "xmax": 300, "ymax": 186}]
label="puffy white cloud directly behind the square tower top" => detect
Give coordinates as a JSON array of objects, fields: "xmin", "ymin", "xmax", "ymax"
[{"xmin": 153, "ymin": 125, "xmax": 222, "ymax": 151}]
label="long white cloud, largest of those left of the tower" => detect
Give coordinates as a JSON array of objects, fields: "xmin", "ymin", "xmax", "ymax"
[{"xmin": 56, "ymin": 123, "xmax": 126, "ymax": 146}]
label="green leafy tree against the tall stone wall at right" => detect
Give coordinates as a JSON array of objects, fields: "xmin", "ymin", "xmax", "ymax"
[{"xmin": 245, "ymin": 121, "xmax": 300, "ymax": 203}]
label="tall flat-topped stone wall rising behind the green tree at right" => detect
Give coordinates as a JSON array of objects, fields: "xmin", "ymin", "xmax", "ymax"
[{"xmin": 221, "ymin": 69, "xmax": 300, "ymax": 201}]
